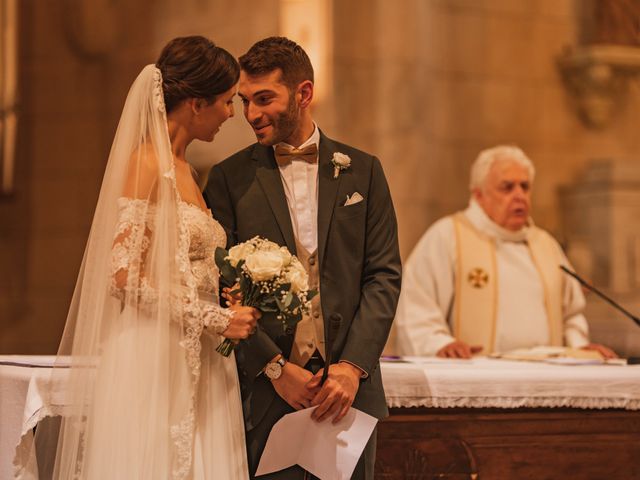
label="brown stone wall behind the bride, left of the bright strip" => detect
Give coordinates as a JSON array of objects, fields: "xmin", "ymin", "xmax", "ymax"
[{"xmin": 0, "ymin": 0, "xmax": 278, "ymax": 354}]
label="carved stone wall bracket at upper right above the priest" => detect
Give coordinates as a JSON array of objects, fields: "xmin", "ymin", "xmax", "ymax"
[{"xmin": 558, "ymin": 45, "xmax": 640, "ymax": 129}]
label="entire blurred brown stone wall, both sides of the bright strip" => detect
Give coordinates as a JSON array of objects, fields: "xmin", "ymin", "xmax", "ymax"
[{"xmin": 0, "ymin": 0, "xmax": 640, "ymax": 353}]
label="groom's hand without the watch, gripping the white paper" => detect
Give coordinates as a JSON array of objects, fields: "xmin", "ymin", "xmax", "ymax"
[{"xmin": 307, "ymin": 362, "xmax": 362, "ymax": 423}]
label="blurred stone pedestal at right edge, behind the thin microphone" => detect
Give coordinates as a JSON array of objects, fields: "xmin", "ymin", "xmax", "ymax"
[{"xmin": 560, "ymin": 159, "xmax": 640, "ymax": 355}]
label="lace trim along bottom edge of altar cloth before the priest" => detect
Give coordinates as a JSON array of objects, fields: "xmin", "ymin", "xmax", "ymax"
[{"xmin": 387, "ymin": 397, "xmax": 640, "ymax": 410}]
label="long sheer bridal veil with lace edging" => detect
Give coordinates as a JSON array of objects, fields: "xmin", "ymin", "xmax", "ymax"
[{"xmin": 18, "ymin": 65, "xmax": 244, "ymax": 479}]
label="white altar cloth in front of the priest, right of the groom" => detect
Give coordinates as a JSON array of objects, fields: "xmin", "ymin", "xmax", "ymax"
[{"xmin": 381, "ymin": 357, "xmax": 640, "ymax": 410}]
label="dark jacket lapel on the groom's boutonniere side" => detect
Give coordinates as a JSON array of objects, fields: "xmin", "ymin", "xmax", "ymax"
[{"xmin": 318, "ymin": 132, "xmax": 342, "ymax": 267}]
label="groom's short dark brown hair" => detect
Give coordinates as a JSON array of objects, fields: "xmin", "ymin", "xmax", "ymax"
[{"xmin": 239, "ymin": 37, "xmax": 313, "ymax": 89}]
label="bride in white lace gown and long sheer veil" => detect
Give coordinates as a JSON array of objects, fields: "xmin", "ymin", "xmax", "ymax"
[{"xmin": 23, "ymin": 37, "xmax": 259, "ymax": 479}]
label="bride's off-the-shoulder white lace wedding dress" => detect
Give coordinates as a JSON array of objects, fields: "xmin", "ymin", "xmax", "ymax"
[{"xmin": 76, "ymin": 198, "xmax": 248, "ymax": 480}]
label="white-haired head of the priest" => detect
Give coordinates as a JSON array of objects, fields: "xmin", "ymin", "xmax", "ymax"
[{"xmin": 469, "ymin": 145, "xmax": 535, "ymax": 231}]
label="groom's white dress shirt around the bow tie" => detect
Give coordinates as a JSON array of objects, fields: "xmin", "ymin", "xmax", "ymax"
[{"xmin": 274, "ymin": 123, "xmax": 320, "ymax": 253}]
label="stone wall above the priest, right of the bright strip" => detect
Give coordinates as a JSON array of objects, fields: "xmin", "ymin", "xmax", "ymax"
[{"xmin": 334, "ymin": 0, "xmax": 640, "ymax": 258}]
